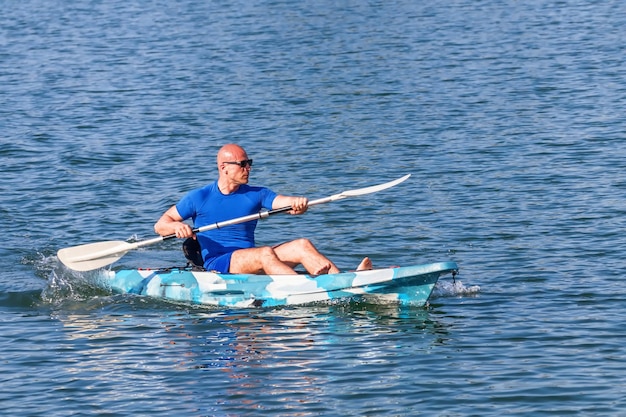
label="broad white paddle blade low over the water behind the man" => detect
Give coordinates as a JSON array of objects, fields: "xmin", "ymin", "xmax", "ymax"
[{"xmin": 57, "ymin": 240, "xmax": 134, "ymax": 272}]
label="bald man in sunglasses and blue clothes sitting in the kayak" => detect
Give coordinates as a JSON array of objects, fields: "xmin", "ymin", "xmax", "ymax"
[{"xmin": 154, "ymin": 144, "xmax": 372, "ymax": 275}]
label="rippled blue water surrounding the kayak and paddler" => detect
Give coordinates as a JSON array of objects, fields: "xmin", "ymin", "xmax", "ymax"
[{"xmin": 0, "ymin": 0, "xmax": 626, "ymax": 416}]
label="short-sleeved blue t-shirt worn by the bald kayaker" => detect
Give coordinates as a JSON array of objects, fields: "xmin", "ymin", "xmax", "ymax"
[{"xmin": 176, "ymin": 181, "xmax": 277, "ymax": 261}]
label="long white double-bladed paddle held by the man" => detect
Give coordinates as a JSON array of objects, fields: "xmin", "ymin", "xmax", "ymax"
[{"xmin": 57, "ymin": 174, "xmax": 411, "ymax": 271}]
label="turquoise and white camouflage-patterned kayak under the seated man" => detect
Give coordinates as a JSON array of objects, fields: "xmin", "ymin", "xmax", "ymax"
[{"xmin": 101, "ymin": 262, "xmax": 458, "ymax": 308}]
